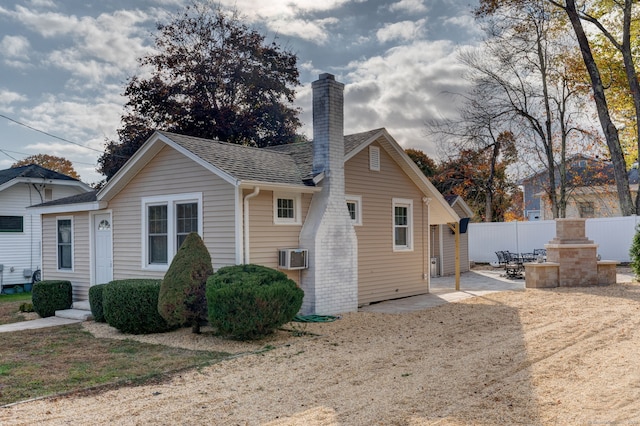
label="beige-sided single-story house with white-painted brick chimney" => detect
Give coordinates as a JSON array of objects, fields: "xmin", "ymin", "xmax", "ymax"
[{"xmin": 33, "ymin": 74, "xmax": 459, "ymax": 314}]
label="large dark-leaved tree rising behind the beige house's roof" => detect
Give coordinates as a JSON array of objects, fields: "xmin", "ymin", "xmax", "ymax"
[{"xmin": 98, "ymin": 2, "xmax": 300, "ymax": 180}]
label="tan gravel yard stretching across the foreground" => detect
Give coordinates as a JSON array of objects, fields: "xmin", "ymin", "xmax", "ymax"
[{"xmin": 0, "ymin": 283, "xmax": 640, "ymax": 426}]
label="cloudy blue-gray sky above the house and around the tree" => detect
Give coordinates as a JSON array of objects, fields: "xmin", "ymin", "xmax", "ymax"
[{"xmin": 0, "ymin": 0, "xmax": 481, "ymax": 183}]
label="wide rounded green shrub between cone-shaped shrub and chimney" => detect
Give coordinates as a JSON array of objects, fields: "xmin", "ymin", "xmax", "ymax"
[{"xmin": 207, "ymin": 265, "xmax": 304, "ymax": 339}]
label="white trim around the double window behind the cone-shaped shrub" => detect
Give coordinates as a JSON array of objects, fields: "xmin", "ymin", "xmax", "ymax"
[{"xmin": 141, "ymin": 192, "xmax": 203, "ymax": 271}]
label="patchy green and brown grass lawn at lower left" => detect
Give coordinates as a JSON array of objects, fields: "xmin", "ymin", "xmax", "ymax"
[{"xmin": 0, "ymin": 293, "xmax": 228, "ymax": 406}]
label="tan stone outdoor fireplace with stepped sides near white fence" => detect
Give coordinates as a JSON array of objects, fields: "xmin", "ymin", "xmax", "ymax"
[{"xmin": 524, "ymin": 219, "xmax": 618, "ymax": 288}]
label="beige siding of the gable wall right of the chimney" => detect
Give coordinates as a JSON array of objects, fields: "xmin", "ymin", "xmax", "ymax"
[{"xmin": 345, "ymin": 143, "xmax": 428, "ymax": 305}]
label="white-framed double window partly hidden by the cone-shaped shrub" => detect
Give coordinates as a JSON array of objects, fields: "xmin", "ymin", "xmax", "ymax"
[{"xmin": 142, "ymin": 193, "xmax": 202, "ymax": 270}]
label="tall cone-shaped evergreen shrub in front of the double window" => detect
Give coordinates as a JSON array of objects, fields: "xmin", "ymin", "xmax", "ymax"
[{"xmin": 158, "ymin": 232, "xmax": 213, "ymax": 333}]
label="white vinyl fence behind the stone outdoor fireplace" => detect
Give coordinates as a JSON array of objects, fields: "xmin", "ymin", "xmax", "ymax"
[{"xmin": 467, "ymin": 216, "xmax": 640, "ymax": 263}]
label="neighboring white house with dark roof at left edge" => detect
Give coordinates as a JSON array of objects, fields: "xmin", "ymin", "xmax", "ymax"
[{"xmin": 0, "ymin": 164, "xmax": 92, "ymax": 287}]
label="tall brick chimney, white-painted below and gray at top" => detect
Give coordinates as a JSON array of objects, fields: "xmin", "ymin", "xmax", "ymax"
[{"xmin": 300, "ymin": 74, "xmax": 358, "ymax": 315}]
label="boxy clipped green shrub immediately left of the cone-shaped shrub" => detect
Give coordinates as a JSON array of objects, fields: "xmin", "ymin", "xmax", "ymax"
[{"xmin": 102, "ymin": 279, "xmax": 170, "ymax": 334}]
